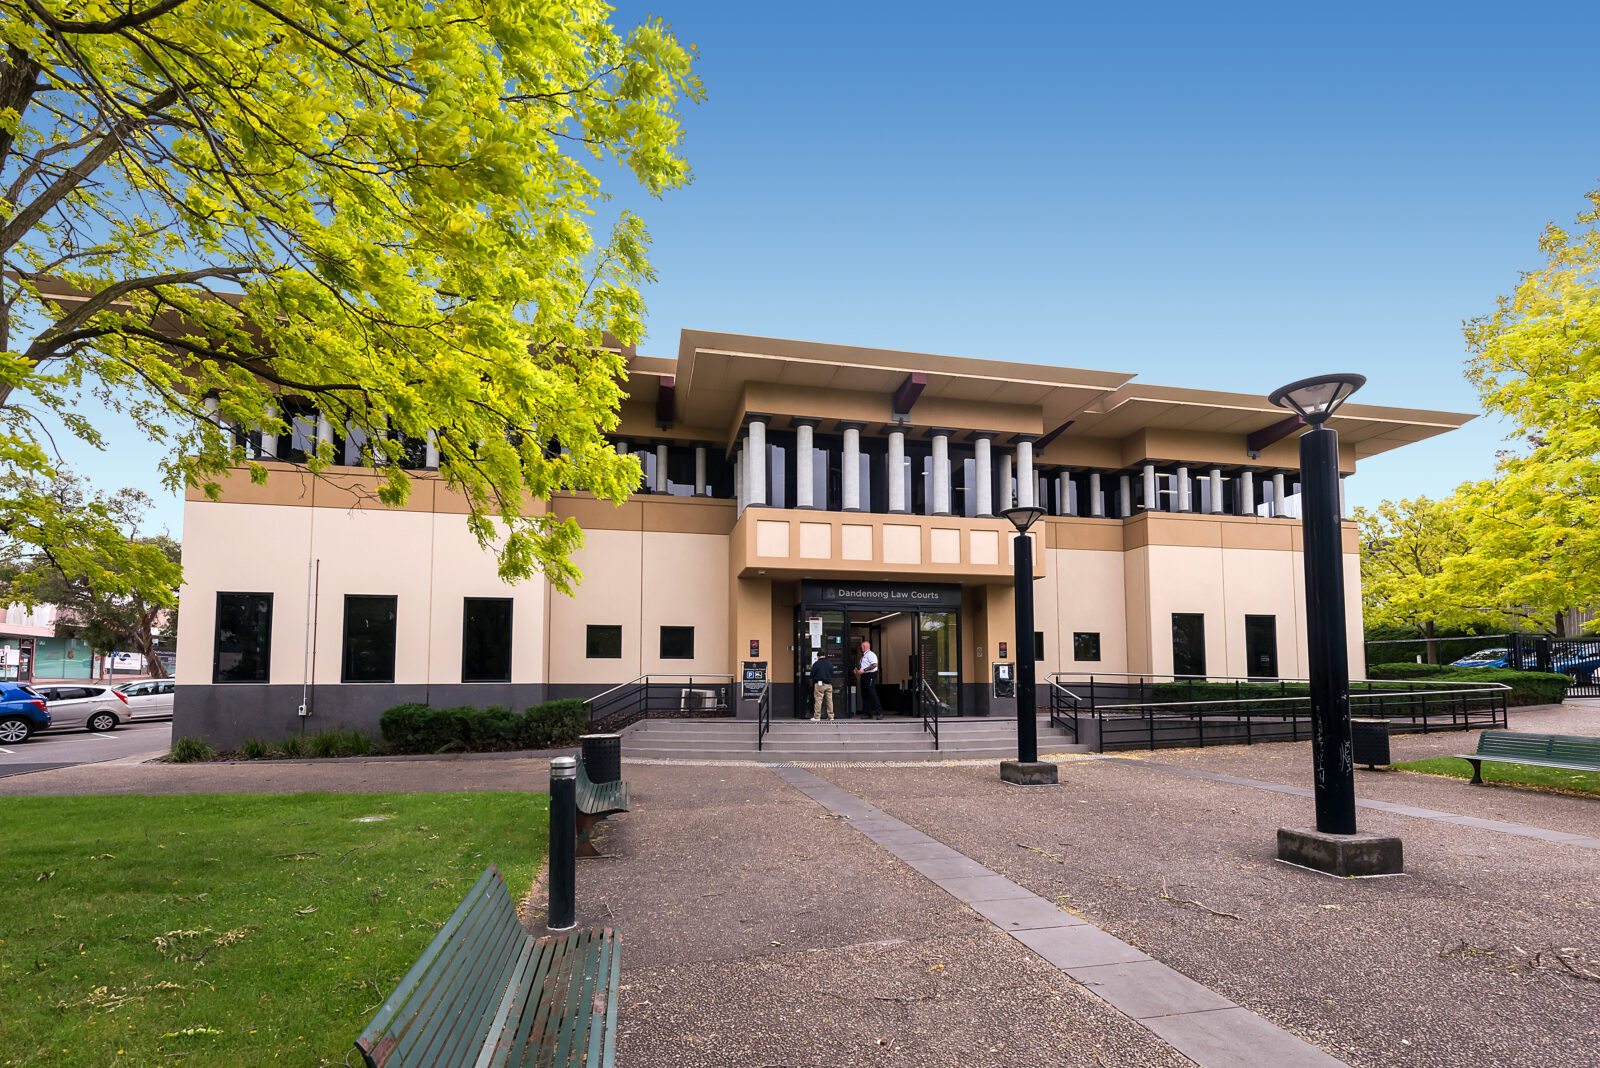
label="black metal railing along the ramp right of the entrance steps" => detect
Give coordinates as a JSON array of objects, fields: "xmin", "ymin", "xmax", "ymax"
[{"xmin": 1050, "ymin": 675, "xmax": 1510, "ymax": 753}]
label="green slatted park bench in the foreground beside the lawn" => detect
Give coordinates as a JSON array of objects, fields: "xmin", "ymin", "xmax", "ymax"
[{"xmin": 355, "ymin": 865, "xmax": 619, "ymax": 1068}]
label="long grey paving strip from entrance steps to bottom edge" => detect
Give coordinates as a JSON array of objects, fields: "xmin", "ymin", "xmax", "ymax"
[{"xmin": 763, "ymin": 761, "xmax": 1344, "ymax": 1068}]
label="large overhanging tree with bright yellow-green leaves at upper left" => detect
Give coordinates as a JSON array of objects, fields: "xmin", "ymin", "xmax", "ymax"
[{"xmin": 0, "ymin": 0, "xmax": 701, "ymax": 588}]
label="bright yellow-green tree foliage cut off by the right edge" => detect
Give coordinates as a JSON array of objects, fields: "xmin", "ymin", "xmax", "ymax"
[{"xmin": 1451, "ymin": 190, "xmax": 1600, "ymax": 630}]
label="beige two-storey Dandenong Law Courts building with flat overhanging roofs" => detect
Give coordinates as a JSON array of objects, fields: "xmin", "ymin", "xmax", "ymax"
[{"xmin": 174, "ymin": 331, "xmax": 1469, "ymax": 743}]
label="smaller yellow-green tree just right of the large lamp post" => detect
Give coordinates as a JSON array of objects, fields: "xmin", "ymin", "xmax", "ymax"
[{"xmin": 1352, "ymin": 497, "xmax": 1485, "ymax": 664}]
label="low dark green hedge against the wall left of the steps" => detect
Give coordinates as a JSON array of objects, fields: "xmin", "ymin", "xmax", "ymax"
[{"xmin": 379, "ymin": 697, "xmax": 589, "ymax": 753}]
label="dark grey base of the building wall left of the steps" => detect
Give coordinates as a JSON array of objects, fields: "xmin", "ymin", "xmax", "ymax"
[{"xmin": 173, "ymin": 683, "xmax": 636, "ymax": 748}]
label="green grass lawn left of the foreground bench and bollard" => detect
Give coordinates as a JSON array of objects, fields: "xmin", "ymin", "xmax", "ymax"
[{"xmin": 0, "ymin": 793, "xmax": 549, "ymax": 1068}]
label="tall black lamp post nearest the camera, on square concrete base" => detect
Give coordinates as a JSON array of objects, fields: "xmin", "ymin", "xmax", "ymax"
[{"xmin": 1267, "ymin": 374, "xmax": 1400, "ymax": 876}]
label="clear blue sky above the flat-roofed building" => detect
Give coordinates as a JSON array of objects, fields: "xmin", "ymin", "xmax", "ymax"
[{"xmin": 50, "ymin": 0, "xmax": 1600, "ymax": 531}]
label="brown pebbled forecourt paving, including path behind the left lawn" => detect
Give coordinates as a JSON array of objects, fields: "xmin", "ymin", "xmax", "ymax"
[{"xmin": 0, "ymin": 710, "xmax": 1600, "ymax": 1068}]
